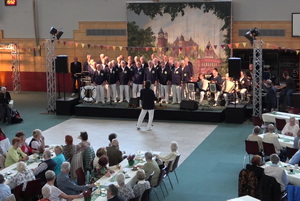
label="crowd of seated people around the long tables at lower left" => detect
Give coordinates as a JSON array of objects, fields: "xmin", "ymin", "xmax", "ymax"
[{"xmin": 0, "ymin": 129, "xmax": 179, "ymax": 201}]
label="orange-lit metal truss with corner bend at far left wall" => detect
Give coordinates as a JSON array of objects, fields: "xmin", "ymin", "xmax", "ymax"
[{"xmin": 0, "ymin": 43, "xmax": 21, "ymax": 93}]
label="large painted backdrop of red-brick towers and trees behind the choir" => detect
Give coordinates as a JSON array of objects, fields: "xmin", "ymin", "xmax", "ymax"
[{"xmin": 127, "ymin": 2, "xmax": 231, "ymax": 75}]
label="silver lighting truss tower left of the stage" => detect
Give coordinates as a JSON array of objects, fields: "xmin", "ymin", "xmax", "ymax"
[{"xmin": 45, "ymin": 39, "xmax": 56, "ymax": 113}]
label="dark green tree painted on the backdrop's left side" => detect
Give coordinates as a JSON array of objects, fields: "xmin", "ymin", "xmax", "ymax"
[{"xmin": 127, "ymin": 22, "xmax": 156, "ymax": 59}]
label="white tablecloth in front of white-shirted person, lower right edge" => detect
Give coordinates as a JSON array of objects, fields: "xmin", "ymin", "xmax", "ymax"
[{"xmin": 262, "ymin": 161, "xmax": 300, "ymax": 186}]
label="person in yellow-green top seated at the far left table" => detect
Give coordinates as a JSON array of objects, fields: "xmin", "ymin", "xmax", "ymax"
[{"xmin": 5, "ymin": 137, "xmax": 28, "ymax": 167}]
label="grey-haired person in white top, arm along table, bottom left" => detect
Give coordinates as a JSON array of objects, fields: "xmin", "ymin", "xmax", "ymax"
[{"xmin": 42, "ymin": 170, "xmax": 83, "ymax": 201}]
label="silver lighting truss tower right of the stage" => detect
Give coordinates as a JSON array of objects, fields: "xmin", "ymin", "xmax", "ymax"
[{"xmin": 252, "ymin": 40, "xmax": 262, "ymax": 117}]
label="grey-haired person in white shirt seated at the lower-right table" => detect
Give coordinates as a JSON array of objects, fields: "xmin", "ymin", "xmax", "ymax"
[{"xmin": 264, "ymin": 154, "xmax": 288, "ymax": 192}]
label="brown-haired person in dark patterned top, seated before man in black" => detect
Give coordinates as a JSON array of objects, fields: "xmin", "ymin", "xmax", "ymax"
[{"xmin": 91, "ymin": 155, "xmax": 114, "ymax": 183}]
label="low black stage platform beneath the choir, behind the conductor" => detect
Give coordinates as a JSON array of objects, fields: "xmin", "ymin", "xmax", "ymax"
[{"xmin": 75, "ymin": 102, "xmax": 226, "ymax": 122}]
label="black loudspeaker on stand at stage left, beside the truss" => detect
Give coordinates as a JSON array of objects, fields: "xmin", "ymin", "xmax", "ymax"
[{"xmin": 55, "ymin": 55, "xmax": 68, "ymax": 100}]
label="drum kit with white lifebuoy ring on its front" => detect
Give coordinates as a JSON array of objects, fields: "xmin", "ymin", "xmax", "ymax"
[{"xmin": 76, "ymin": 71, "xmax": 96, "ymax": 103}]
